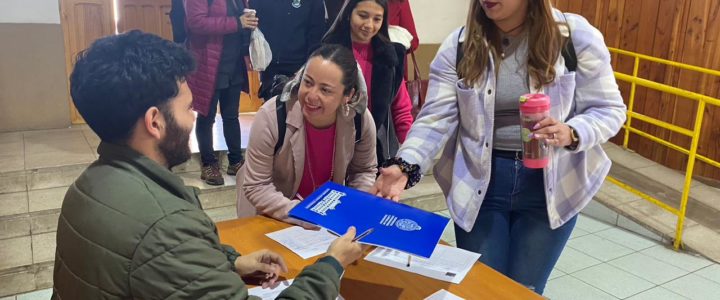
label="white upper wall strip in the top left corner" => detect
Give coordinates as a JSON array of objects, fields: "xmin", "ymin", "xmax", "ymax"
[{"xmin": 0, "ymin": 0, "xmax": 60, "ymax": 24}]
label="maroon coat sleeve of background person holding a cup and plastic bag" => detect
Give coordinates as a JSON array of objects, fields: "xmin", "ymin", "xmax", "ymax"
[{"xmin": 185, "ymin": 0, "xmax": 239, "ymax": 35}]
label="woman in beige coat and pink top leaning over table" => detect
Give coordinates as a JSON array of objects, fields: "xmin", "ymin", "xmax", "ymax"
[{"xmin": 237, "ymin": 45, "xmax": 377, "ymax": 227}]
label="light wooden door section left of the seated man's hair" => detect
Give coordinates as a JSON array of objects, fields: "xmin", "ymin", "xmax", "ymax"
[{"xmin": 60, "ymin": 0, "xmax": 115, "ymax": 124}]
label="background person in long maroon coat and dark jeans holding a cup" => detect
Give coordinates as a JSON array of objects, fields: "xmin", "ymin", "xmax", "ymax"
[{"xmin": 185, "ymin": 0, "xmax": 258, "ymax": 185}]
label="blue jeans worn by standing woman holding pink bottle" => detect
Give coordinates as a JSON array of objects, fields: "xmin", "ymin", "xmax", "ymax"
[{"xmin": 455, "ymin": 151, "xmax": 577, "ymax": 294}]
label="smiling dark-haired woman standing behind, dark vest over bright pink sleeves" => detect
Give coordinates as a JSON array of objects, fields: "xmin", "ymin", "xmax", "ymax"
[{"xmin": 323, "ymin": 0, "xmax": 413, "ymax": 163}]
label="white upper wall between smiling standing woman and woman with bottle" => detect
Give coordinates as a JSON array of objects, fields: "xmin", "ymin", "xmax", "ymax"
[{"xmin": 408, "ymin": 0, "xmax": 477, "ymax": 44}]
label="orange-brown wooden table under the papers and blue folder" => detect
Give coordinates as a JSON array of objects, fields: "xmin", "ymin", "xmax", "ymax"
[{"xmin": 217, "ymin": 216, "xmax": 543, "ymax": 300}]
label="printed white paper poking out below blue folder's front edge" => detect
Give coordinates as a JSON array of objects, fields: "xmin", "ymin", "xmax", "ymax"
[{"xmin": 365, "ymin": 245, "xmax": 480, "ymax": 284}]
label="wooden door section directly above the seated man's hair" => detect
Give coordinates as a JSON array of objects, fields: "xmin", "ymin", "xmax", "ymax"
[{"xmin": 117, "ymin": 0, "xmax": 172, "ymax": 40}]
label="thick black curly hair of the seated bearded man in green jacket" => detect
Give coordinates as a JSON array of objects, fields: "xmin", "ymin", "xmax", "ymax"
[{"xmin": 70, "ymin": 30, "xmax": 195, "ymax": 144}]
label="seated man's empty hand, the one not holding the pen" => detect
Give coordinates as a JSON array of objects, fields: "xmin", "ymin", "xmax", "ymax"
[{"xmin": 235, "ymin": 249, "xmax": 288, "ymax": 288}]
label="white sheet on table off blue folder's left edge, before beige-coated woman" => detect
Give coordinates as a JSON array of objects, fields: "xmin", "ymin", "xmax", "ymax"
[{"xmin": 266, "ymin": 226, "xmax": 337, "ymax": 259}]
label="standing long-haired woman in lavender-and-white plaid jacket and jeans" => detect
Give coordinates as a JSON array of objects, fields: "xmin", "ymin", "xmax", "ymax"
[{"xmin": 371, "ymin": 0, "xmax": 625, "ymax": 294}]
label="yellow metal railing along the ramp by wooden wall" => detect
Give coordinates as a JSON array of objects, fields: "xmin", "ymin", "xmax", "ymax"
[{"xmin": 608, "ymin": 48, "xmax": 720, "ymax": 249}]
